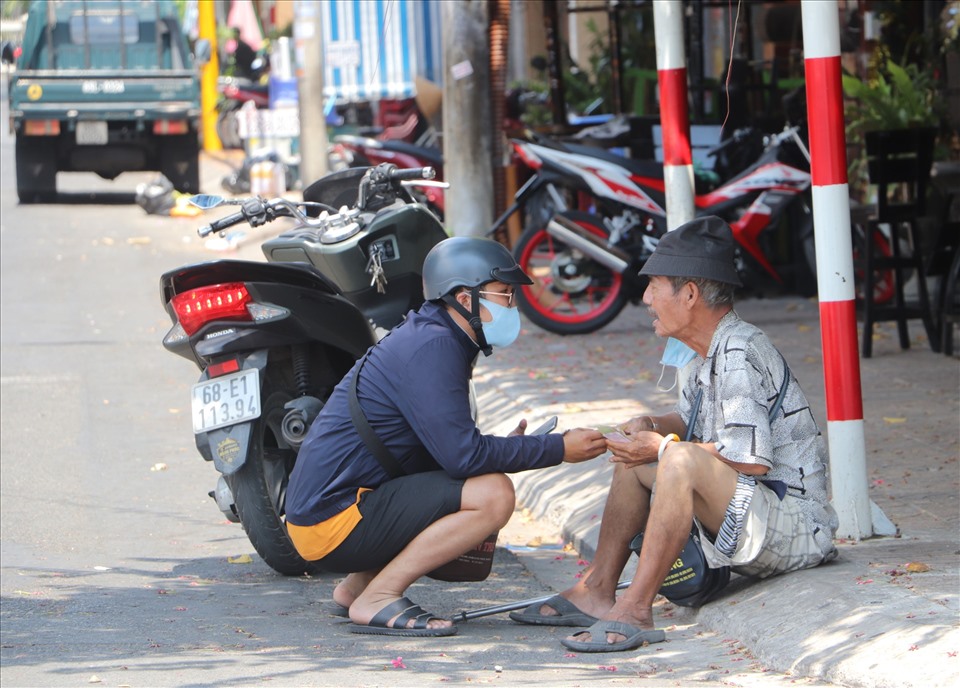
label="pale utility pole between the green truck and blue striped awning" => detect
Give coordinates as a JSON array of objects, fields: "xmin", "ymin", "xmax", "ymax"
[{"xmin": 293, "ymin": 0, "xmax": 328, "ymax": 187}]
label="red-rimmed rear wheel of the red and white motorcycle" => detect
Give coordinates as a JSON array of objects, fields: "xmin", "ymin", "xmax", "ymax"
[{"xmin": 514, "ymin": 212, "xmax": 627, "ymax": 334}]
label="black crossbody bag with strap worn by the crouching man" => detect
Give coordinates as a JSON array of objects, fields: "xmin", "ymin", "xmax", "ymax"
[{"xmin": 349, "ymin": 355, "xmax": 500, "ymax": 583}]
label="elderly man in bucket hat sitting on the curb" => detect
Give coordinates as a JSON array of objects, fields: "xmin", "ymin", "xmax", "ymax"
[{"xmin": 511, "ymin": 217, "xmax": 837, "ymax": 652}]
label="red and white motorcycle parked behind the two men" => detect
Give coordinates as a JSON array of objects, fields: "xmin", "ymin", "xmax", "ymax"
[{"xmin": 490, "ymin": 127, "xmax": 816, "ymax": 334}]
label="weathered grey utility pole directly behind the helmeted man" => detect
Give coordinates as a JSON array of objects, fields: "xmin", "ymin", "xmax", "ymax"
[{"xmin": 440, "ymin": 0, "xmax": 494, "ymax": 236}]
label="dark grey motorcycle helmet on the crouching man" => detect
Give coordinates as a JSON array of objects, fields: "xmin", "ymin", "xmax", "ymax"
[{"xmin": 423, "ymin": 237, "xmax": 533, "ymax": 301}]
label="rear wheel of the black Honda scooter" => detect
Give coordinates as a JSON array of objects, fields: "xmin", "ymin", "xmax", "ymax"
[{"xmin": 226, "ymin": 378, "xmax": 319, "ymax": 576}]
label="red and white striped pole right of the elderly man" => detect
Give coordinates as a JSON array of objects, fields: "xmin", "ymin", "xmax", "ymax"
[{"xmin": 801, "ymin": 0, "xmax": 873, "ymax": 540}]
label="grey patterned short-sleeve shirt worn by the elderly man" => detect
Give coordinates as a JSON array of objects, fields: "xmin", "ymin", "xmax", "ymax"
[{"xmin": 676, "ymin": 310, "xmax": 837, "ymax": 554}]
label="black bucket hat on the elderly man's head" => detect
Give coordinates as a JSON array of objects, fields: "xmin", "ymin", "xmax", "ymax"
[{"xmin": 640, "ymin": 215, "xmax": 741, "ymax": 287}]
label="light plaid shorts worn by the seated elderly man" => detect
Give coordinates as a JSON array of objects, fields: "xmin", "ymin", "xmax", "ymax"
[{"xmin": 697, "ymin": 483, "xmax": 835, "ymax": 578}]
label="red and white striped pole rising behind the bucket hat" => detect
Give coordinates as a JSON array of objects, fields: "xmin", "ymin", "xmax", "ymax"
[{"xmin": 653, "ymin": 0, "xmax": 695, "ymax": 230}]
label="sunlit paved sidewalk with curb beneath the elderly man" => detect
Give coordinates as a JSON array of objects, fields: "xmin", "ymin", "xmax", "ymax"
[{"xmin": 474, "ymin": 298, "xmax": 960, "ymax": 688}]
